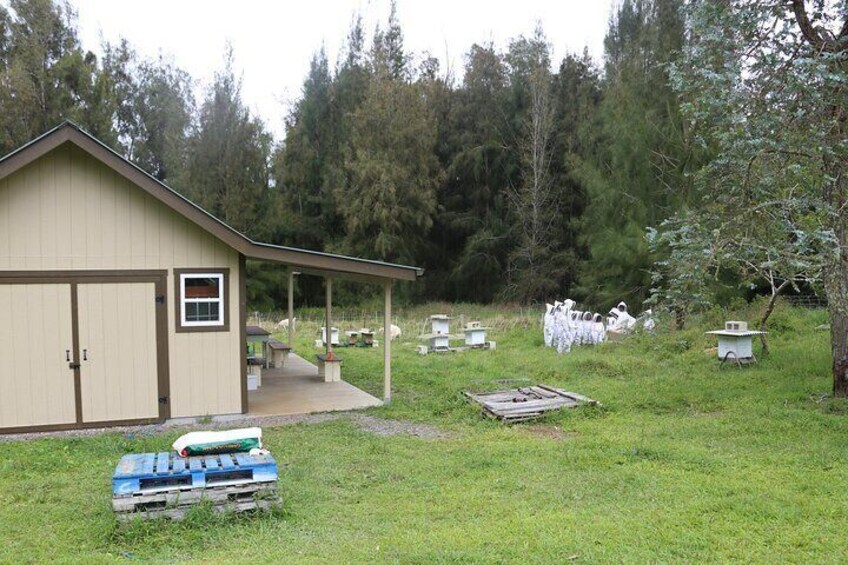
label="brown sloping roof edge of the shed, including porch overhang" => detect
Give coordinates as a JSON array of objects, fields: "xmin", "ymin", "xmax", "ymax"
[{"xmin": 0, "ymin": 121, "xmax": 424, "ymax": 282}]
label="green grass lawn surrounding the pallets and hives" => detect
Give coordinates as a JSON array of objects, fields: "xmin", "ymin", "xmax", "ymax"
[{"xmin": 0, "ymin": 307, "xmax": 848, "ymax": 563}]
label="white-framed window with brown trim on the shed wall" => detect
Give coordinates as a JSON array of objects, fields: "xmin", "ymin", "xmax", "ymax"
[{"xmin": 175, "ymin": 270, "xmax": 228, "ymax": 331}]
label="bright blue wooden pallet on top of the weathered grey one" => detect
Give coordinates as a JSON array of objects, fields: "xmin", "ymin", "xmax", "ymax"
[{"xmin": 112, "ymin": 451, "xmax": 277, "ymax": 496}]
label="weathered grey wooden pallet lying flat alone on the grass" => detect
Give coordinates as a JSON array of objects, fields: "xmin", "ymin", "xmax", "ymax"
[{"xmin": 465, "ymin": 385, "xmax": 598, "ymax": 422}]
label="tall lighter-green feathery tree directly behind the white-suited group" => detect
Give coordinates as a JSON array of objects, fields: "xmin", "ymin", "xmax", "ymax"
[{"xmin": 579, "ymin": 0, "xmax": 693, "ymax": 305}]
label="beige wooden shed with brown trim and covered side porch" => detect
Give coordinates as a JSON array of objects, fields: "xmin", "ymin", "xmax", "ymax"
[{"xmin": 0, "ymin": 122, "xmax": 422, "ymax": 433}]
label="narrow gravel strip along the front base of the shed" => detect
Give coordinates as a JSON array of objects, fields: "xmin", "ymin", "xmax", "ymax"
[{"xmin": 0, "ymin": 412, "xmax": 449, "ymax": 443}]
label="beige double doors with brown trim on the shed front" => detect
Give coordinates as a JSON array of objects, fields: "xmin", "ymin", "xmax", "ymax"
[{"xmin": 0, "ymin": 273, "xmax": 168, "ymax": 432}]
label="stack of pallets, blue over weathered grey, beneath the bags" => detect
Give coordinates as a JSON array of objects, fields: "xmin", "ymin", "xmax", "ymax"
[{"xmin": 112, "ymin": 452, "xmax": 281, "ymax": 520}]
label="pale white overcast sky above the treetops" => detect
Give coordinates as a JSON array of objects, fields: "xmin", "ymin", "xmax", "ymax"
[{"xmin": 66, "ymin": 0, "xmax": 612, "ymax": 139}]
